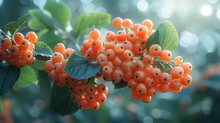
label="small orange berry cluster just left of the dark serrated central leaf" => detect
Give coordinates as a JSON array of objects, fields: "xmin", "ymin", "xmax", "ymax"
[{"xmin": 44, "ymin": 43, "xmax": 74, "ymax": 87}]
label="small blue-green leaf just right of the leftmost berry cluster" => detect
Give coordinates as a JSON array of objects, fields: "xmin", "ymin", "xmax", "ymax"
[{"xmin": 34, "ymin": 41, "xmax": 53, "ymax": 57}]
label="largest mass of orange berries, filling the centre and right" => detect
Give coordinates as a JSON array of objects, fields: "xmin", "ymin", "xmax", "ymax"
[{"xmin": 81, "ymin": 17, "xmax": 192, "ymax": 103}]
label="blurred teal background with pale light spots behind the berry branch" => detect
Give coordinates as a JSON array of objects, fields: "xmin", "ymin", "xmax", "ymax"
[{"xmin": 0, "ymin": 0, "xmax": 220, "ymax": 123}]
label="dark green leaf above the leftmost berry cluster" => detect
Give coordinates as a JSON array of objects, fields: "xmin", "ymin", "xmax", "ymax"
[{"xmin": 5, "ymin": 15, "xmax": 30, "ymax": 34}]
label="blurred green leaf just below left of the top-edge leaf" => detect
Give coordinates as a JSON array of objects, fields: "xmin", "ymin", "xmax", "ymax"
[{"xmin": 28, "ymin": 9, "xmax": 55, "ymax": 30}]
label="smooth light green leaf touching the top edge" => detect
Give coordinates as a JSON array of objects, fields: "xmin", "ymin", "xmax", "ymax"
[{"xmin": 44, "ymin": 0, "xmax": 71, "ymax": 27}]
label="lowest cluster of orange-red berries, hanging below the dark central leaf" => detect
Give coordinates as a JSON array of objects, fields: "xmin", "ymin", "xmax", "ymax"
[{"xmin": 70, "ymin": 80, "xmax": 108, "ymax": 110}]
